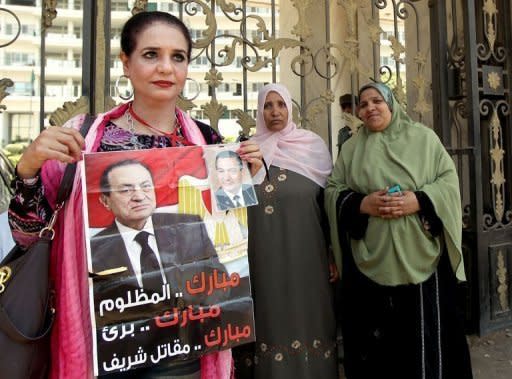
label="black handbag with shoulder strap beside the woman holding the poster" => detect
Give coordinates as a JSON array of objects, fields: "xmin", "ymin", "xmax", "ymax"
[{"xmin": 0, "ymin": 115, "xmax": 94, "ymax": 379}]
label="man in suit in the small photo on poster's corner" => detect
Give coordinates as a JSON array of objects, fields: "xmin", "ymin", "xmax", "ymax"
[{"xmin": 215, "ymin": 150, "xmax": 258, "ymax": 211}]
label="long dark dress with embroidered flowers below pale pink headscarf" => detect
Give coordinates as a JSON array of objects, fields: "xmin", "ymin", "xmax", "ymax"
[{"xmin": 234, "ymin": 166, "xmax": 338, "ymax": 379}]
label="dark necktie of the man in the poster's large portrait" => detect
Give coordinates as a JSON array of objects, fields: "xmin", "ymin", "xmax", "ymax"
[{"xmin": 134, "ymin": 231, "xmax": 162, "ymax": 292}]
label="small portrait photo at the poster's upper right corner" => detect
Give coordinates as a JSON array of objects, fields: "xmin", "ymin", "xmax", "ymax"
[{"xmin": 206, "ymin": 148, "xmax": 258, "ymax": 211}]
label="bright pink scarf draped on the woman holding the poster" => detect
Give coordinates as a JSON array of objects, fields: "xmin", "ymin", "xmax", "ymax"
[{"xmin": 41, "ymin": 104, "xmax": 233, "ymax": 379}]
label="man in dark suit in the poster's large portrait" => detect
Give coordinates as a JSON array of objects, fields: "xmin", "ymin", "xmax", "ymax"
[{"xmin": 91, "ymin": 160, "xmax": 224, "ymax": 296}]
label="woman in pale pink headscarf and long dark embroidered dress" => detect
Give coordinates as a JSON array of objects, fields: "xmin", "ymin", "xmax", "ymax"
[{"xmin": 236, "ymin": 84, "xmax": 338, "ymax": 379}]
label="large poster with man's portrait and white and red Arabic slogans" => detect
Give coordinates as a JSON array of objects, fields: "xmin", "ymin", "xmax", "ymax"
[{"xmin": 82, "ymin": 144, "xmax": 255, "ymax": 375}]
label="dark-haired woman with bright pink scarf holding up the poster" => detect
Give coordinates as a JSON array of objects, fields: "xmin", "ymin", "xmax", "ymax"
[{"xmin": 9, "ymin": 12, "xmax": 261, "ymax": 379}]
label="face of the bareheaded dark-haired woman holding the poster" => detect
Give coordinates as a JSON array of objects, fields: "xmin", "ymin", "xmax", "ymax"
[{"xmin": 121, "ymin": 22, "xmax": 188, "ymax": 102}]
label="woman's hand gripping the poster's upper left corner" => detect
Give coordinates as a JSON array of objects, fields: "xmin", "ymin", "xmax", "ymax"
[{"xmin": 17, "ymin": 126, "xmax": 85, "ymax": 179}]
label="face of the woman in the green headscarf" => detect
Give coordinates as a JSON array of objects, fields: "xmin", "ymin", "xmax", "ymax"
[{"xmin": 359, "ymin": 88, "xmax": 392, "ymax": 132}]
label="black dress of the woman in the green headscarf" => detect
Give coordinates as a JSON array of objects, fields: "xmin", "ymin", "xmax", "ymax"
[{"xmin": 338, "ymin": 191, "xmax": 473, "ymax": 379}]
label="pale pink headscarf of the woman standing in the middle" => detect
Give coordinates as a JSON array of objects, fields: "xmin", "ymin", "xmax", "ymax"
[{"xmin": 251, "ymin": 84, "xmax": 332, "ymax": 188}]
